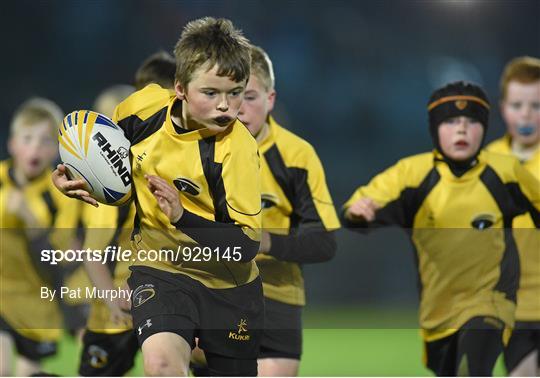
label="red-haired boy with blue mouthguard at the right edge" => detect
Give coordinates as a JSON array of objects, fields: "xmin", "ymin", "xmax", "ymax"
[{"xmin": 486, "ymin": 57, "xmax": 540, "ymax": 376}]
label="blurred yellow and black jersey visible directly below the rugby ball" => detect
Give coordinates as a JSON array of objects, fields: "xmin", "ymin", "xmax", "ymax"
[{"xmin": 83, "ymin": 203, "xmax": 135, "ymax": 333}]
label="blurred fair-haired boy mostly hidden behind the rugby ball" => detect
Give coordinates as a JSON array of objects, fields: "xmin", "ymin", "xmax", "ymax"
[{"xmin": 79, "ymin": 85, "xmax": 138, "ymax": 376}]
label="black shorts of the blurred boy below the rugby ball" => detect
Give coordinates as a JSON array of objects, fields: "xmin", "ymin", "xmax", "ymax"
[{"xmin": 79, "ymin": 330, "xmax": 139, "ymax": 377}]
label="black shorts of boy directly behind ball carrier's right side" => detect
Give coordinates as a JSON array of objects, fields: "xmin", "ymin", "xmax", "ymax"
[{"xmin": 259, "ymin": 297, "xmax": 302, "ymax": 360}]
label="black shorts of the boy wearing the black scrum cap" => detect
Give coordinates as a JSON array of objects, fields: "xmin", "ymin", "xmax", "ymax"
[{"xmin": 425, "ymin": 317, "xmax": 504, "ymax": 376}]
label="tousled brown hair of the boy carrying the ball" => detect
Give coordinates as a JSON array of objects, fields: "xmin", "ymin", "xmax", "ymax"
[{"xmin": 174, "ymin": 17, "xmax": 251, "ymax": 91}]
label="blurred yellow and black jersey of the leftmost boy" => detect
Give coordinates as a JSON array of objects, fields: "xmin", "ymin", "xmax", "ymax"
[{"xmin": 0, "ymin": 160, "xmax": 77, "ymax": 341}]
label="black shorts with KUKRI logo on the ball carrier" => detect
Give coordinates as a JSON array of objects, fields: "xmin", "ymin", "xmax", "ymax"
[{"xmin": 128, "ymin": 266, "xmax": 264, "ymax": 359}]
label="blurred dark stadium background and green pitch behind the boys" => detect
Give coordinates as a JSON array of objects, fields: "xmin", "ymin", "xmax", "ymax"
[{"xmin": 0, "ymin": 0, "xmax": 540, "ymax": 376}]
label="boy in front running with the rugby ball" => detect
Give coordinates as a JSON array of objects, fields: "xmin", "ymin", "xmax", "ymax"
[{"xmin": 53, "ymin": 17, "xmax": 263, "ymax": 376}]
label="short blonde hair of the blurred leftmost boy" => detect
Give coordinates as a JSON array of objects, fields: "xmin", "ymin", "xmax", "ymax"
[{"xmin": 10, "ymin": 97, "xmax": 64, "ymax": 137}]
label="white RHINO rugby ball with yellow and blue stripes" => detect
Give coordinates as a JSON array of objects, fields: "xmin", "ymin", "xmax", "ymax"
[{"xmin": 58, "ymin": 110, "xmax": 131, "ymax": 206}]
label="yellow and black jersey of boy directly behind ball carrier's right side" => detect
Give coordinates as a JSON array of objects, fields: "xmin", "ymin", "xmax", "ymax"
[{"xmin": 256, "ymin": 117, "xmax": 340, "ymax": 305}]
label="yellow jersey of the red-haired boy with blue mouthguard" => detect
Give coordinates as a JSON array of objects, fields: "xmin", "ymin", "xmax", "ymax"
[{"xmin": 486, "ymin": 135, "xmax": 540, "ymax": 321}]
